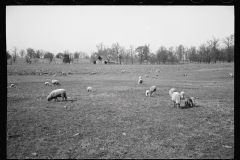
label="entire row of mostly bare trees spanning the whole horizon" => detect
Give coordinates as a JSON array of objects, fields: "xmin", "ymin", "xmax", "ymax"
[{"xmin": 7, "ymin": 35, "xmax": 234, "ymax": 64}]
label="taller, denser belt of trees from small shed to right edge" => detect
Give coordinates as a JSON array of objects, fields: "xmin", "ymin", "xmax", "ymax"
[{"xmin": 90, "ymin": 35, "xmax": 234, "ymax": 64}]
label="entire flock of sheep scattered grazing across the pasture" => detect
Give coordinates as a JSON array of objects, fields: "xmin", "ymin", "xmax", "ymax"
[{"xmin": 7, "ymin": 70, "xmax": 234, "ymax": 108}]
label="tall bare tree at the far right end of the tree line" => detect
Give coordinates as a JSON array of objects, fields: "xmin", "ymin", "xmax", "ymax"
[{"xmin": 223, "ymin": 35, "xmax": 234, "ymax": 62}]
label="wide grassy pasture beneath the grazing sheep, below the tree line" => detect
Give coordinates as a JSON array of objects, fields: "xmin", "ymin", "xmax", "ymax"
[{"xmin": 7, "ymin": 59, "xmax": 234, "ymax": 159}]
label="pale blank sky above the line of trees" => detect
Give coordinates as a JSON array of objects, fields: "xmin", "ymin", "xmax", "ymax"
[{"xmin": 6, "ymin": 5, "xmax": 235, "ymax": 54}]
